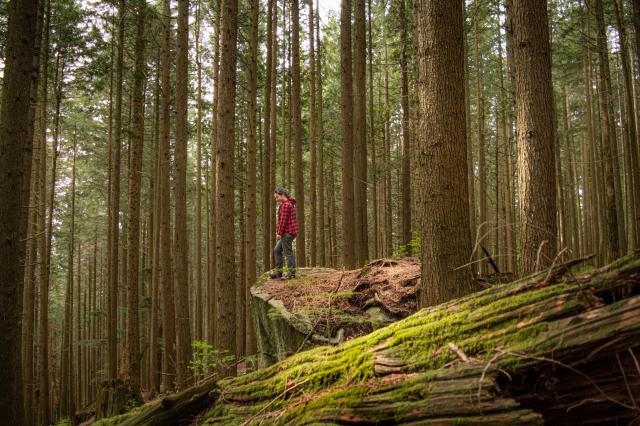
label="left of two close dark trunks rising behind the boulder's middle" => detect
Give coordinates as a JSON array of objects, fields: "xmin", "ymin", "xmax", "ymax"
[{"xmin": 340, "ymin": 0, "xmax": 356, "ymax": 268}]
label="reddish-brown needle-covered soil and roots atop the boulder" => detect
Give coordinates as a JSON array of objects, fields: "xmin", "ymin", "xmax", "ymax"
[{"xmin": 263, "ymin": 257, "xmax": 420, "ymax": 339}]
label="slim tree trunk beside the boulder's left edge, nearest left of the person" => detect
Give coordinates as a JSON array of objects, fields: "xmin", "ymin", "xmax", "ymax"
[{"xmin": 243, "ymin": 0, "xmax": 260, "ymax": 355}]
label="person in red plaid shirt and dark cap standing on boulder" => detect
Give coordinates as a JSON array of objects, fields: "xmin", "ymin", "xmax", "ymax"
[{"xmin": 269, "ymin": 188, "xmax": 298, "ymax": 279}]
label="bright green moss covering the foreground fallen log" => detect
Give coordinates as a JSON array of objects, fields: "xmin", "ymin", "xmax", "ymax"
[{"xmin": 201, "ymin": 253, "xmax": 640, "ymax": 424}]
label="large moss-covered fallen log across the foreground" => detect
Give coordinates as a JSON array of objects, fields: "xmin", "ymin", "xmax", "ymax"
[{"xmin": 203, "ymin": 254, "xmax": 640, "ymax": 425}]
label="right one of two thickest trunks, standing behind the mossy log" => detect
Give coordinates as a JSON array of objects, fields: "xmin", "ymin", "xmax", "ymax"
[{"xmin": 509, "ymin": 0, "xmax": 557, "ymax": 274}]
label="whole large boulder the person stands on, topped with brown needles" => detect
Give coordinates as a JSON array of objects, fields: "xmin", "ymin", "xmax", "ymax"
[{"xmin": 251, "ymin": 258, "xmax": 420, "ymax": 367}]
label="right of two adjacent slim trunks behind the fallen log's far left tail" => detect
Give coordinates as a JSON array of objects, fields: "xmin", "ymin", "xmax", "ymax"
[{"xmin": 174, "ymin": 0, "xmax": 191, "ymax": 389}]
